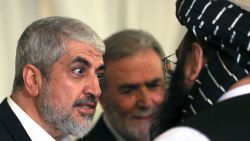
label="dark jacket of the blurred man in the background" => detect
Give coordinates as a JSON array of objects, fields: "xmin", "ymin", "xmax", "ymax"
[{"xmin": 78, "ymin": 115, "xmax": 116, "ymax": 141}]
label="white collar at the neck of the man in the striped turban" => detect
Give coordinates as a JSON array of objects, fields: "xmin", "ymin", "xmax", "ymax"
[{"xmin": 217, "ymin": 84, "xmax": 250, "ymax": 102}]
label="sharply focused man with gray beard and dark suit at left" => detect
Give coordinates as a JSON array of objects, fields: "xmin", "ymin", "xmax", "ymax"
[{"xmin": 0, "ymin": 17, "xmax": 105, "ymax": 141}]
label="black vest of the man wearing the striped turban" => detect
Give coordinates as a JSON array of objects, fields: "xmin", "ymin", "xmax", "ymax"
[{"xmin": 181, "ymin": 94, "xmax": 250, "ymax": 141}]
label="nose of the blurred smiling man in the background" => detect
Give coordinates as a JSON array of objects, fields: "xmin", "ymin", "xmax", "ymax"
[{"xmin": 137, "ymin": 86, "xmax": 153, "ymax": 109}]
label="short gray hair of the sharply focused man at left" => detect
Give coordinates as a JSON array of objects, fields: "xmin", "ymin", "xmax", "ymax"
[{"xmin": 12, "ymin": 17, "xmax": 105, "ymax": 92}]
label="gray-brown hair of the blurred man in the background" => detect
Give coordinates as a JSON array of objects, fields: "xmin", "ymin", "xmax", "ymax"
[{"xmin": 104, "ymin": 29, "xmax": 165, "ymax": 63}]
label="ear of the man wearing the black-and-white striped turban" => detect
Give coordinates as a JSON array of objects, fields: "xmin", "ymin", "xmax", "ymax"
[{"xmin": 187, "ymin": 42, "xmax": 205, "ymax": 81}]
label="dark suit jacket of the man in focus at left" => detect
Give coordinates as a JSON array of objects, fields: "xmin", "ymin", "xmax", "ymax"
[{"xmin": 0, "ymin": 98, "xmax": 31, "ymax": 141}]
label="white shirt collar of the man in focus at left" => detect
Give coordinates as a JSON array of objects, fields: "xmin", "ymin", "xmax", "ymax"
[{"xmin": 7, "ymin": 97, "xmax": 55, "ymax": 141}]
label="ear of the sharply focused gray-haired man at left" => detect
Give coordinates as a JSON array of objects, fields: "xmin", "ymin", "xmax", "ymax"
[{"xmin": 23, "ymin": 64, "xmax": 42, "ymax": 97}]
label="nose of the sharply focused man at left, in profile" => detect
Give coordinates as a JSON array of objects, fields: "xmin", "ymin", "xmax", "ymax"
[{"xmin": 86, "ymin": 74, "xmax": 101, "ymax": 98}]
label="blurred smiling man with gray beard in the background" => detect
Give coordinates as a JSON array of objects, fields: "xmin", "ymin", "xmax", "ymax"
[{"xmin": 79, "ymin": 30, "xmax": 168, "ymax": 141}]
